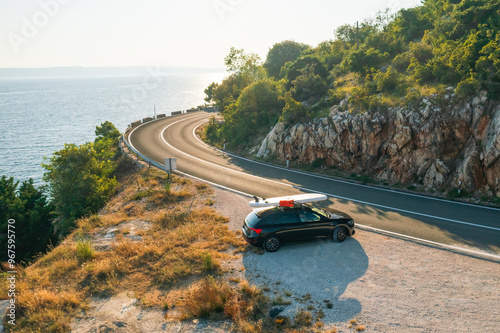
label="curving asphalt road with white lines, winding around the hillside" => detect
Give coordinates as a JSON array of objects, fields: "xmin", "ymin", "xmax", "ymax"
[{"xmin": 129, "ymin": 112, "xmax": 500, "ymax": 254}]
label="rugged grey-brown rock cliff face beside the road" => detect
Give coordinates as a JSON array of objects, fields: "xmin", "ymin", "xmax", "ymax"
[{"xmin": 257, "ymin": 87, "xmax": 500, "ymax": 196}]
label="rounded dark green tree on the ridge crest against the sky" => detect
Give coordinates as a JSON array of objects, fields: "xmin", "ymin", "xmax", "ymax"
[{"xmin": 264, "ymin": 40, "xmax": 309, "ymax": 78}]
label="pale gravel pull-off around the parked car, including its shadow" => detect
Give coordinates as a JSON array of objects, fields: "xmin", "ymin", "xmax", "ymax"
[{"xmin": 214, "ymin": 189, "xmax": 500, "ymax": 332}]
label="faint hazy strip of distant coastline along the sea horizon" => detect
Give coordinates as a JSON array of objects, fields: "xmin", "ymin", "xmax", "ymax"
[{"xmin": 0, "ymin": 66, "xmax": 225, "ymax": 80}]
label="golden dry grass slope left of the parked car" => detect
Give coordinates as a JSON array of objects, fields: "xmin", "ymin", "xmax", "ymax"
[{"xmin": 8, "ymin": 165, "xmax": 332, "ymax": 332}]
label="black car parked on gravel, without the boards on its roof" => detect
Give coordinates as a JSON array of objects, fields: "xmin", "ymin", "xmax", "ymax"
[{"xmin": 242, "ymin": 204, "xmax": 355, "ymax": 252}]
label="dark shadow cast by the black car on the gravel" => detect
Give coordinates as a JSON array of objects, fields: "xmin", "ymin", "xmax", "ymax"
[{"xmin": 243, "ymin": 238, "xmax": 368, "ymax": 323}]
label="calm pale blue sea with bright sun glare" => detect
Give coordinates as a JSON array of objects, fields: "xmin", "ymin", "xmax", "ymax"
[{"xmin": 0, "ymin": 73, "xmax": 225, "ymax": 185}]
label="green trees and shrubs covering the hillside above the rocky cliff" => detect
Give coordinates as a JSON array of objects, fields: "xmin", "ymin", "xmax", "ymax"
[{"xmin": 205, "ymin": 0, "xmax": 500, "ymax": 149}]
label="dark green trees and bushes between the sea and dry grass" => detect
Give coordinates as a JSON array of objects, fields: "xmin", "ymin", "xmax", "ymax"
[{"xmin": 0, "ymin": 121, "xmax": 122, "ymax": 263}]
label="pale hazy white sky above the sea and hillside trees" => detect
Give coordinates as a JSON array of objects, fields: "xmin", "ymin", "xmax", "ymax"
[{"xmin": 0, "ymin": 0, "xmax": 421, "ymax": 67}]
